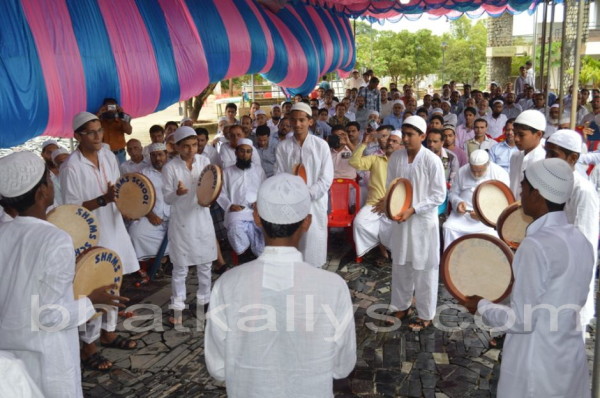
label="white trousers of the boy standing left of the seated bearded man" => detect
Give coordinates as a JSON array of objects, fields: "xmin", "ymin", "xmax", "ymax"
[{"xmin": 170, "ymin": 263, "xmax": 212, "ymax": 311}]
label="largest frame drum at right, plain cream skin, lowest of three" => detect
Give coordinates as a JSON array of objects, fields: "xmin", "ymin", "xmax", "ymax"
[{"xmin": 441, "ymin": 234, "xmax": 513, "ymax": 303}]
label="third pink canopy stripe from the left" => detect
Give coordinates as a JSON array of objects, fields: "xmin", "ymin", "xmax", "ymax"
[{"xmin": 158, "ymin": 0, "xmax": 209, "ymax": 99}]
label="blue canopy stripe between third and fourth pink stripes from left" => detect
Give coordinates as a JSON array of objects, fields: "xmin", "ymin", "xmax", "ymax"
[{"xmin": 186, "ymin": 0, "xmax": 231, "ymax": 82}]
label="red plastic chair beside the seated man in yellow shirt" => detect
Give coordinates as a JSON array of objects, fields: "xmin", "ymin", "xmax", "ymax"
[{"xmin": 327, "ymin": 178, "xmax": 362, "ymax": 261}]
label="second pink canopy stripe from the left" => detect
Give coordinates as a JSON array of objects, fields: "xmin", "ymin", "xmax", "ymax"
[{"xmin": 98, "ymin": 0, "xmax": 160, "ymax": 116}]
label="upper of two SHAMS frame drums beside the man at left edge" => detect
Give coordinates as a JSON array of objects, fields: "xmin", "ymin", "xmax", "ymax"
[{"xmin": 46, "ymin": 205, "xmax": 100, "ymax": 257}]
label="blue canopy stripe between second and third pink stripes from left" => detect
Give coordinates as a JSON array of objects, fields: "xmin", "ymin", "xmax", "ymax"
[{"xmin": 135, "ymin": 0, "xmax": 180, "ymax": 111}]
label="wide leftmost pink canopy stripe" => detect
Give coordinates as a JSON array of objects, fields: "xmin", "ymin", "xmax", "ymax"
[{"xmin": 21, "ymin": 0, "xmax": 86, "ymax": 138}]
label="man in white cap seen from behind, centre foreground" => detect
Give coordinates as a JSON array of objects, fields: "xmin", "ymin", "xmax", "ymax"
[{"xmin": 204, "ymin": 173, "xmax": 356, "ymax": 398}]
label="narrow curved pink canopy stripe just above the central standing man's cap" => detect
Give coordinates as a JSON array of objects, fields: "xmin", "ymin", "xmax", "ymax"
[{"xmin": 265, "ymin": 10, "xmax": 308, "ymax": 88}]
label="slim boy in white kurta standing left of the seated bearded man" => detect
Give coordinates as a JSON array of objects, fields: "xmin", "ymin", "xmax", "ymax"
[{"xmin": 162, "ymin": 126, "xmax": 217, "ymax": 323}]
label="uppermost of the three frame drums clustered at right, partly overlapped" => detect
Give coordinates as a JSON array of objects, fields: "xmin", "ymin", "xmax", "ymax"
[{"xmin": 473, "ymin": 180, "xmax": 515, "ymax": 228}]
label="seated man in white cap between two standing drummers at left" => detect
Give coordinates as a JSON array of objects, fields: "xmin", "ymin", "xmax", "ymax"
[{"xmin": 129, "ymin": 143, "xmax": 171, "ymax": 271}]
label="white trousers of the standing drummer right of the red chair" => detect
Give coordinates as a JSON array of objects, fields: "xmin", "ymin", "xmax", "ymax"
[{"xmin": 391, "ymin": 263, "xmax": 439, "ymax": 321}]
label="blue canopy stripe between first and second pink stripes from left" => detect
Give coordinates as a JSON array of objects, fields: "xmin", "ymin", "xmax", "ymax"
[{"xmin": 67, "ymin": 0, "xmax": 121, "ymax": 112}]
